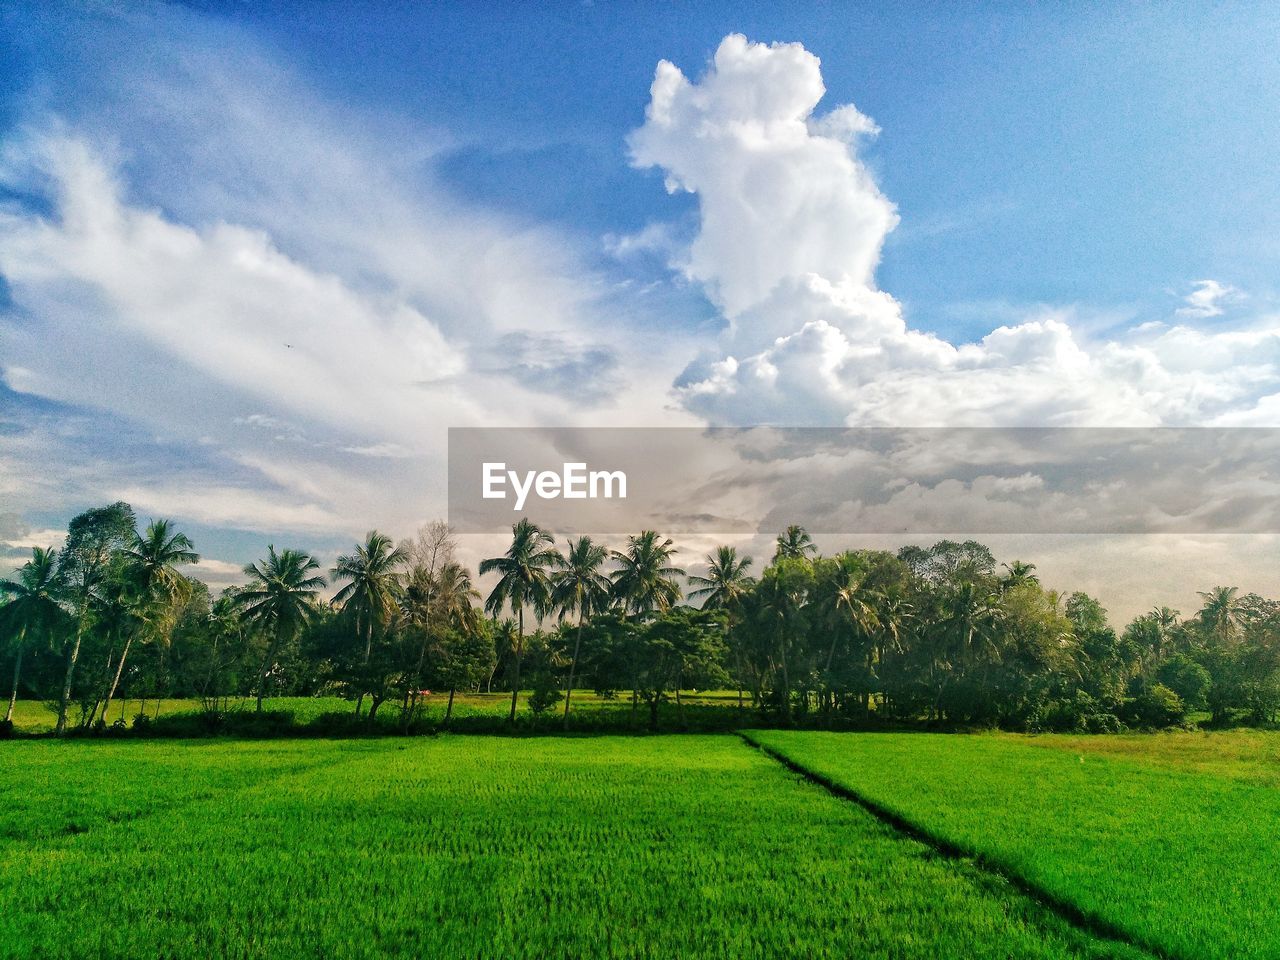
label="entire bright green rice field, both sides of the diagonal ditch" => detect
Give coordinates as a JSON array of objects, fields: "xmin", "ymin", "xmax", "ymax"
[{"xmin": 0, "ymin": 727, "xmax": 1280, "ymax": 960}]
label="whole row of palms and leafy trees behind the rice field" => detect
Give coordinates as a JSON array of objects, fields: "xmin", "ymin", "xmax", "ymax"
[{"xmin": 0, "ymin": 503, "xmax": 1280, "ymax": 735}]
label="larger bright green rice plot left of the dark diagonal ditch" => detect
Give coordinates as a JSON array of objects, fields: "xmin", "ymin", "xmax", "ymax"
[{"xmin": 0, "ymin": 736, "xmax": 1152, "ymax": 960}]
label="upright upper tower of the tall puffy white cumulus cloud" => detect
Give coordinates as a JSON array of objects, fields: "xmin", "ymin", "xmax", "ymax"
[{"xmin": 630, "ymin": 35, "xmax": 897, "ymax": 317}]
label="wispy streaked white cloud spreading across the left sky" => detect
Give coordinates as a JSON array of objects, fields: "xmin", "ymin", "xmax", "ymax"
[{"xmin": 0, "ymin": 8, "xmax": 690, "ymax": 545}]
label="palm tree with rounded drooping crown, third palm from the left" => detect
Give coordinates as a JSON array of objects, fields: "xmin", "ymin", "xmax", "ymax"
[{"xmin": 236, "ymin": 547, "xmax": 324, "ymax": 713}]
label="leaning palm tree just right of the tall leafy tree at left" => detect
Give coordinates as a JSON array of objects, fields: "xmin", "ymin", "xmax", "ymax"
[{"xmin": 97, "ymin": 520, "xmax": 200, "ymax": 721}]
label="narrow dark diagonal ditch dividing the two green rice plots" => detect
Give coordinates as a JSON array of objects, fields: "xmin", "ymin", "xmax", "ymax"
[{"xmin": 737, "ymin": 730, "xmax": 1177, "ymax": 960}]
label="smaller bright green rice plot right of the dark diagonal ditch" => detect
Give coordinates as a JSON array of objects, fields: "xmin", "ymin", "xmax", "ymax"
[{"xmin": 750, "ymin": 731, "xmax": 1280, "ymax": 960}]
